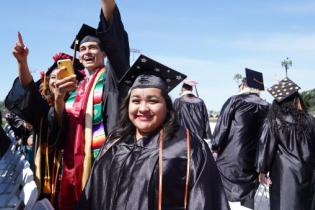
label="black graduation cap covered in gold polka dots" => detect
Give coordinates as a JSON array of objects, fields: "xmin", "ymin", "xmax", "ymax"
[{"xmin": 267, "ymin": 77, "xmax": 301, "ymax": 102}]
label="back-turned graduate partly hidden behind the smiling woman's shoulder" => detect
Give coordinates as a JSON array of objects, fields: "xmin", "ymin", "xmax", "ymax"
[{"xmin": 174, "ymin": 79, "xmax": 212, "ymax": 140}]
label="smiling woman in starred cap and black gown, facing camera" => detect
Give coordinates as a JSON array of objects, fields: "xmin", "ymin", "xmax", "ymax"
[{"xmin": 77, "ymin": 55, "xmax": 229, "ymax": 210}]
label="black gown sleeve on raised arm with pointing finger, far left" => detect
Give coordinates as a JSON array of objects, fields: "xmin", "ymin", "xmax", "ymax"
[{"xmin": 5, "ymin": 78, "xmax": 49, "ymax": 129}]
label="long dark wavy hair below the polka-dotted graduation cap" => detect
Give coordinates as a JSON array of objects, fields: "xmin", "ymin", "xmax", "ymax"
[{"xmin": 267, "ymin": 93, "xmax": 311, "ymax": 133}]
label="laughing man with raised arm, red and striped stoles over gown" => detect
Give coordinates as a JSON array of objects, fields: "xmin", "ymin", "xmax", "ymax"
[{"xmin": 55, "ymin": 0, "xmax": 129, "ymax": 209}]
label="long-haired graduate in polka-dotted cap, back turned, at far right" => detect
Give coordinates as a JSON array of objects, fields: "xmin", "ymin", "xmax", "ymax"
[{"xmin": 257, "ymin": 77, "xmax": 315, "ymax": 210}]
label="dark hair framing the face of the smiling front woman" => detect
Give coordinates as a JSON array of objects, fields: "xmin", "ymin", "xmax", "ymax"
[{"xmin": 110, "ymin": 89, "xmax": 178, "ymax": 142}]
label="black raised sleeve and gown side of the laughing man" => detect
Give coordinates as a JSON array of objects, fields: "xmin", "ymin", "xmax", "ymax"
[{"xmin": 97, "ymin": 5, "xmax": 130, "ymax": 135}]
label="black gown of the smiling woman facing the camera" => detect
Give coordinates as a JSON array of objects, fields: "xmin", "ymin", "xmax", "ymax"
[{"xmin": 77, "ymin": 128, "xmax": 229, "ymax": 210}]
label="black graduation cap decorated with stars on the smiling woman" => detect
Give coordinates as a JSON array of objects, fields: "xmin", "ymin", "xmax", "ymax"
[{"xmin": 119, "ymin": 55, "xmax": 187, "ymax": 92}]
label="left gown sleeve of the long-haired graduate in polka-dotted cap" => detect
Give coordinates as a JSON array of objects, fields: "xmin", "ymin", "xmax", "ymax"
[{"xmin": 257, "ymin": 119, "xmax": 277, "ymax": 173}]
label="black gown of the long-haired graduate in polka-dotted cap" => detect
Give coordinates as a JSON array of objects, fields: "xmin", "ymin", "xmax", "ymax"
[{"xmin": 258, "ymin": 115, "xmax": 315, "ymax": 210}]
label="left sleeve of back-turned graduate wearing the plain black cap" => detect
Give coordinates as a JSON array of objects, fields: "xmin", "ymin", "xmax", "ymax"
[{"xmin": 212, "ymin": 97, "xmax": 236, "ymax": 150}]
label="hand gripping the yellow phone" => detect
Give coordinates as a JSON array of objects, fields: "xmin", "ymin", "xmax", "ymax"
[{"xmin": 53, "ymin": 70, "xmax": 78, "ymax": 100}]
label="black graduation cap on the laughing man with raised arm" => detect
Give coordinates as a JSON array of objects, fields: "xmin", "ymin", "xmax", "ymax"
[{"xmin": 71, "ymin": 24, "xmax": 101, "ymax": 51}]
